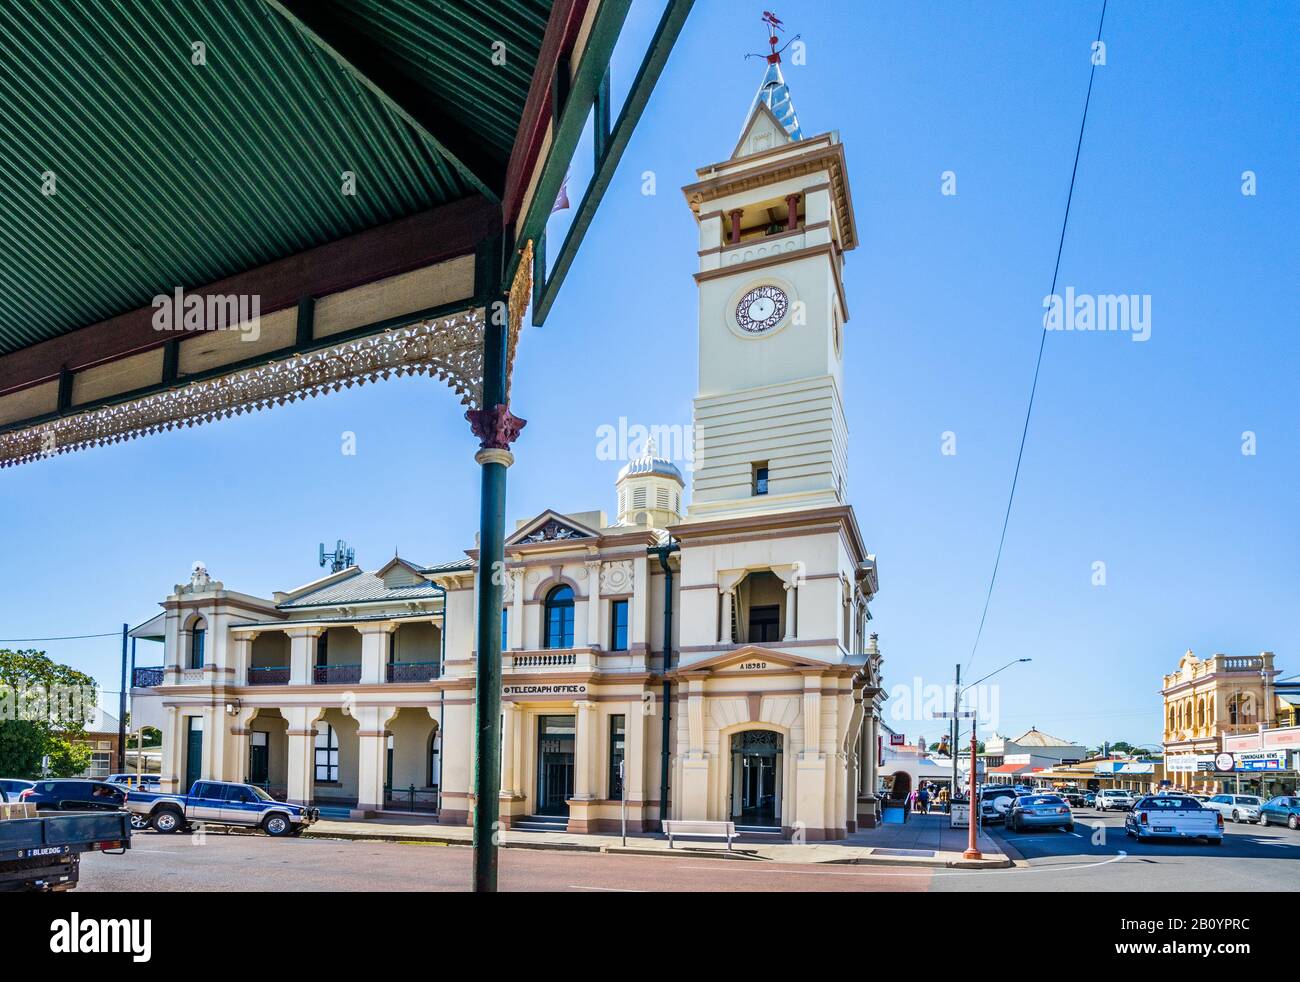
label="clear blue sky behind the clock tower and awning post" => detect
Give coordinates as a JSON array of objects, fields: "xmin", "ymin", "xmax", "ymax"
[{"xmin": 0, "ymin": 0, "xmax": 1300, "ymax": 743}]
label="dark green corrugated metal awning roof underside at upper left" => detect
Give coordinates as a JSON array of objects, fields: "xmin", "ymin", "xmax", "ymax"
[{"xmin": 0, "ymin": 0, "xmax": 551, "ymax": 355}]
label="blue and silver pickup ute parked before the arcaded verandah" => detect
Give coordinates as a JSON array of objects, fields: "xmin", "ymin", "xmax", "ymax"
[{"xmin": 127, "ymin": 780, "xmax": 321, "ymax": 836}]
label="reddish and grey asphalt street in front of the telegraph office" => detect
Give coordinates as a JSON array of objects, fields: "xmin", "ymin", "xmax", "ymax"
[{"xmin": 79, "ymin": 812, "xmax": 1300, "ymax": 892}]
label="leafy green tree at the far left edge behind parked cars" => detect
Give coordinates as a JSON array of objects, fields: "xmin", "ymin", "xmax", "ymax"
[{"xmin": 0, "ymin": 648, "xmax": 98, "ymax": 778}]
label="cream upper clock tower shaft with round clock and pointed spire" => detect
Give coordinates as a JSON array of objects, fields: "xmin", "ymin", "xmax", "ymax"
[{"xmin": 683, "ymin": 46, "xmax": 858, "ymax": 522}]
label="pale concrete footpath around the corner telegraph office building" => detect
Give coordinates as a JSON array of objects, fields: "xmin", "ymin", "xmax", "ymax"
[{"xmin": 306, "ymin": 814, "xmax": 1015, "ymax": 869}]
